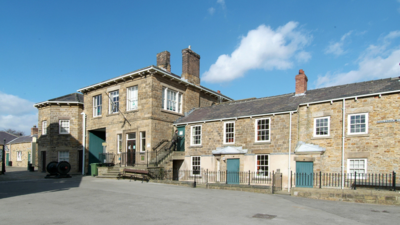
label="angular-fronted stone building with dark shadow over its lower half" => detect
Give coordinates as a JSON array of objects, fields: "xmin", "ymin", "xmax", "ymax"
[{"xmin": 34, "ymin": 93, "xmax": 83, "ymax": 173}]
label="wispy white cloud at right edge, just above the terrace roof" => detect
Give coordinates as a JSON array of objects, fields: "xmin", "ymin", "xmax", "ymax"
[{"xmin": 316, "ymin": 31, "xmax": 400, "ymax": 87}]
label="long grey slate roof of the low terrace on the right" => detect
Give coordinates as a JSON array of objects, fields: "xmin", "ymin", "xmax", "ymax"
[{"xmin": 175, "ymin": 77, "xmax": 400, "ymax": 124}]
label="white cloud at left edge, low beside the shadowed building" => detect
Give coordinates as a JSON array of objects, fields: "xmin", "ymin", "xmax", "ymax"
[{"xmin": 0, "ymin": 92, "xmax": 38, "ymax": 135}]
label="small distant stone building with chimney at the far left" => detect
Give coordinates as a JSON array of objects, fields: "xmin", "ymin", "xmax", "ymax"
[{"xmin": 6, "ymin": 126, "xmax": 38, "ymax": 168}]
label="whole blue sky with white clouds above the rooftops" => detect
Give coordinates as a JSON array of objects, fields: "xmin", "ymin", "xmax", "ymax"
[{"xmin": 0, "ymin": 0, "xmax": 400, "ymax": 133}]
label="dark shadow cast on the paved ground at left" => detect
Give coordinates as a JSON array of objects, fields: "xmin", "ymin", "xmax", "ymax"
[{"xmin": 0, "ymin": 167, "xmax": 82, "ymax": 199}]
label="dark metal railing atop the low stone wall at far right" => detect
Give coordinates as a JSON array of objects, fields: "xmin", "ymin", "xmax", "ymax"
[{"xmin": 290, "ymin": 171, "xmax": 400, "ymax": 190}]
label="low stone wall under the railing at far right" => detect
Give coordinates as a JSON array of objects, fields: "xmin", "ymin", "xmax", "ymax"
[{"xmin": 291, "ymin": 188, "xmax": 400, "ymax": 205}]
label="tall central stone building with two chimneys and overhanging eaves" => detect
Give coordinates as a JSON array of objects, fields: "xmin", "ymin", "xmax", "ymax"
[{"xmin": 78, "ymin": 47, "xmax": 232, "ymax": 172}]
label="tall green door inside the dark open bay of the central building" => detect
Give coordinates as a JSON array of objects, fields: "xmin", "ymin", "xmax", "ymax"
[{"xmin": 87, "ymin": 131, "xmax": 106, "ymax": 174}]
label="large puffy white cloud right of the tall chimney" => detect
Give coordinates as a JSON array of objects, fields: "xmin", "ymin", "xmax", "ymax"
[{"xmin": 202, "ymin": 22, "xmax": 311, "ymax": 83}]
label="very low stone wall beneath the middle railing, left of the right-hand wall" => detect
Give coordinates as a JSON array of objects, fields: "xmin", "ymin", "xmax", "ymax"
[{"xmin": 150, "ymin": 180, "xmax": 272, "ymax": 194}]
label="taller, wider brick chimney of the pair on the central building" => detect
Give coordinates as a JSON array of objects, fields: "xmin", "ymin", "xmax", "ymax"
[{"xmin": 182, "ymin": 46, "xmax": 200, "ymax": 85}]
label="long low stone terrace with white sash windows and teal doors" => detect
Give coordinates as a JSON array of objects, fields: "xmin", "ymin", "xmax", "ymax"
[{"xmin": 174, "ymin": 70, "xmax": 400, "ymax": 188}]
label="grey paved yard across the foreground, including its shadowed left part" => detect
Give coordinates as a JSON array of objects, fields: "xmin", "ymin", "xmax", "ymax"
[{"xmin": 0, "ymin": 170, "xmax": 400, "ymax": 225}]
